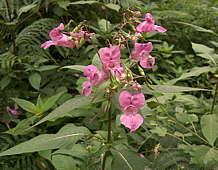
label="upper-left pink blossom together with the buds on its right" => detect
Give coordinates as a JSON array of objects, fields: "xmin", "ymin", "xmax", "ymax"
[{"xmin": 41, "ymin": 23, "xmax": 93, "ymax": 49}]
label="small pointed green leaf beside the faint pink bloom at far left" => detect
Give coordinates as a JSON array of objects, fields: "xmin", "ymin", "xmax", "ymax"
[{"xmin": 12, "ymin": 98, "xmax": 36, "ymax": 113}]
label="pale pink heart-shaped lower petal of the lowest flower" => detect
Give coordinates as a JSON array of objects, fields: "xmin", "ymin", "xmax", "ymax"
[{"xmin": 120, "ymin": 114, "xmax": 144, "ymax": 132}]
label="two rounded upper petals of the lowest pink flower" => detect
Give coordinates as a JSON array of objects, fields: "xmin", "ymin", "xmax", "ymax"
[{"xmin": 119, "ymin": 91, "xmax": 145, "ymax": 110}]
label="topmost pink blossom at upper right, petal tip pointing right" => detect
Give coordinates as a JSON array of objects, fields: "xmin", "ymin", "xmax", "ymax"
[{"xmin": 136, "ymin": 13, "xmax": 167, "ymax": 33}]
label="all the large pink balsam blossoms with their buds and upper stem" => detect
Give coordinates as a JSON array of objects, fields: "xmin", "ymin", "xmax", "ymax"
[{"xmin": 41, "ymin": 12, "xmax": 166, "ymax": 169}]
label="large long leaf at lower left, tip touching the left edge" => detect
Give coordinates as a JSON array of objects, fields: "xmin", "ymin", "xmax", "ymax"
[{"xmin": 0, "ymin": 124, "xmax": 90, "ymax": 156}]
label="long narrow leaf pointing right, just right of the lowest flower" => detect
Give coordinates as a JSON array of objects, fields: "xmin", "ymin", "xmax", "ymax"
[{"xmin": 142, "ymin": 85, "xmax": 209, "ymax": 94}]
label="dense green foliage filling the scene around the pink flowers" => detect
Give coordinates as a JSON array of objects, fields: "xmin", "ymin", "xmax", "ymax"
[{"xmin": 0, "ymin": 0, "xmax": 218, "ymax": 170}]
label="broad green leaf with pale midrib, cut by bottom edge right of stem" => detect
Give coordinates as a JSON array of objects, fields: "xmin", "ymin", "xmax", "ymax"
[{"xmin": 112, "ymin": 150, "xmax": 148, "ymax": 170}]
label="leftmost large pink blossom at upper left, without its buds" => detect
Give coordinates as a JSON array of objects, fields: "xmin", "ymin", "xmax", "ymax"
[{"xmin": 41, "ymin": 23, "xmax": 74, "ymax": 49}]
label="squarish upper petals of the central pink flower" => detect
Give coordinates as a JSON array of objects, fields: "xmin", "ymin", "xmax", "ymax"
[{"xmin": 99, "ymin": 46, "xmax": 121, "ymax": 63}]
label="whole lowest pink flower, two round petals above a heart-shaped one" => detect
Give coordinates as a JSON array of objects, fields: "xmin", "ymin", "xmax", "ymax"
[{"xmin": 119, "ymin": 91, "xmax": 145, "ymax": 132}]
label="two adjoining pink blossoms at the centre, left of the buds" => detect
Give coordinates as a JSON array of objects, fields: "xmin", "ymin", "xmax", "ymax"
[{"xmin": 82, "ymin": 46, "xmax": 124, "ymax": 96}]
